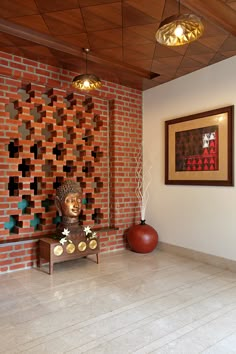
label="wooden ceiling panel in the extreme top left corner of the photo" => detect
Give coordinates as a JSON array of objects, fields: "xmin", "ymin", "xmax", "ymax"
[{"xmin": 0, "ymin": 0, "xmax": 39, "ymax": 18}]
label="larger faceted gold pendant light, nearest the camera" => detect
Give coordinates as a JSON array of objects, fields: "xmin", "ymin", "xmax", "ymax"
[{"xmin": 156, "ymin": 0, "xmax": 204, "ymax": 47}]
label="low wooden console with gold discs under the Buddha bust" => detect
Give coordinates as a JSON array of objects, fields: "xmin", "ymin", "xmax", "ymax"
[{"xmin": 37, "ymin": 237, "xmax": 100, "ymax": 274}]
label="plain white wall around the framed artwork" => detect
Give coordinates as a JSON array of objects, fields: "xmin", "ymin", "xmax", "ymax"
[{"xmin": 143, "ymin": 57, "xmax": 236, "ymax": 260}]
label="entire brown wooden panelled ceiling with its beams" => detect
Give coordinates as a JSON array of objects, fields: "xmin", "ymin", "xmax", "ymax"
[{"xmin": 0, "ymin": 0, "xmax": 236, "ymax": 90}]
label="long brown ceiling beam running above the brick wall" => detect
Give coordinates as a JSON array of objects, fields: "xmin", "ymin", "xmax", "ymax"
[{"xmin": 0, "ymin": 19, "xmax": 160, "ymax": 80}]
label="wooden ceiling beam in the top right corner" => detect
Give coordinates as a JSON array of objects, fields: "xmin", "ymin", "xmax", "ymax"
[{"xmin": 181, "ymin": 0, "xmax": 236, "ymax": 36}]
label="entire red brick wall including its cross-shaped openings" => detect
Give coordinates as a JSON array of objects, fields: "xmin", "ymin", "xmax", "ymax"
[{"xmin": 0, "ymin": 52, "xmax": 142, "ymax": 273}]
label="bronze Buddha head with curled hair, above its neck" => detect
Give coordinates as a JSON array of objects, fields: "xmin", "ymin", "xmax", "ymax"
[{"xmin": 55, "ymin": 180, "xmax": 82, "ymax": 220}]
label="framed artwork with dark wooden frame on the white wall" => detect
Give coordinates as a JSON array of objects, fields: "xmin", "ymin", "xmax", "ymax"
[{"xmin": 165, "ymin": 106, "xmax": 234, "ymax": 186}]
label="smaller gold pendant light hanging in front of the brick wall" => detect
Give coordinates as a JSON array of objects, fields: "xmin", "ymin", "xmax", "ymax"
[{"xmin": 72, "ymin": 48, "xmax": 102, "ymax": 91}]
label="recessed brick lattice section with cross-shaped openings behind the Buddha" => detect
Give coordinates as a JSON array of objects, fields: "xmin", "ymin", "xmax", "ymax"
[{"xmin": 0, "ymin": 84, "xmax": 110, "ymax": 240}]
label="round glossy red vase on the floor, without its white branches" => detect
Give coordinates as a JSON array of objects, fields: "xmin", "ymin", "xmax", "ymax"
[{"xmin": 127, "ymin": 220, "xmax": 158, "ymax": 253}]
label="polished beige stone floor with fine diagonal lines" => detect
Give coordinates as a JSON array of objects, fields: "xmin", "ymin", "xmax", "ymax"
[{"xmin": 0, "ymin": 251, "xmax": 236, "ymax": 354}]
